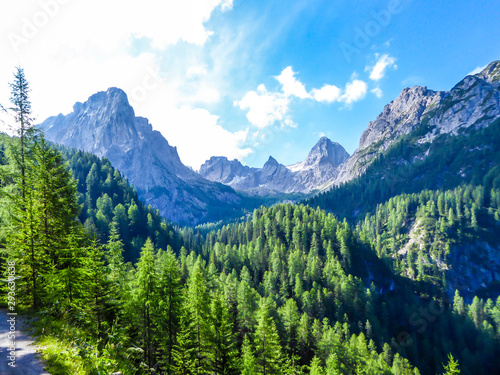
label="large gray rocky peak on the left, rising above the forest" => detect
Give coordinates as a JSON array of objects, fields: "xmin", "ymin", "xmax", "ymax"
[{"xmin": 41, "ymin": 88, "xmax": 241, "ymax": 224}]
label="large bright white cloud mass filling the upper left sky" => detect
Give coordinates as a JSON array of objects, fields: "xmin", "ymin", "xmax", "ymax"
[{"xmin": 0, "ymin": 0, "xmax": 252, "ymax": 168}]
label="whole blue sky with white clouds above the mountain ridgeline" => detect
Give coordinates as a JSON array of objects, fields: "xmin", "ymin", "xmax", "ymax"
[{"xmin": 0, "ymin": 0, "xmax": 500, "ymax": 170}]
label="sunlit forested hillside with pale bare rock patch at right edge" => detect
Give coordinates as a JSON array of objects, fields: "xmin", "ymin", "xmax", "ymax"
[{"xmin": 357, "ymin": 185, "xmax": 500, "ymax": 299}]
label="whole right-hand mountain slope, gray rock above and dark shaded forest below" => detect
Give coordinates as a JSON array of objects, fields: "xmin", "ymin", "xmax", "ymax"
[{"xmin": 308, "ymin": 62, "xmax": 500, "ymax": 220}]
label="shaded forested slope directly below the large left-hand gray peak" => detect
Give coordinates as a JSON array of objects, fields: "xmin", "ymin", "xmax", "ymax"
[{"xmin": 58, "ymin": 146, "xmax": 180, "ymax": 262}]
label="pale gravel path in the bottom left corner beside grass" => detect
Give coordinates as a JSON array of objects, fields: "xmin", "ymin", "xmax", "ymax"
[{"xmin": 0, "ymin": 309, "xmax": 50, "ymax": 375}]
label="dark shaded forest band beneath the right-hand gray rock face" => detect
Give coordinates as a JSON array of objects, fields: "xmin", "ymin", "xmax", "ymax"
[{"xmin": 305, "ymin": 120, "xmax": 500, "ymax": 221}]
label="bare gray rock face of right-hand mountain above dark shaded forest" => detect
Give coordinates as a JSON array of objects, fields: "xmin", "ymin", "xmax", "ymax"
[{"xmin": 327, "ymin": 61, "xmax": 500, "ymax": 187}]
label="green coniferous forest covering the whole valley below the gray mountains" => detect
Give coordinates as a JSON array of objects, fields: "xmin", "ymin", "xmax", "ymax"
[{"xmin": 0, "ymin": 68, "xmax": 500, "ymax": 375}]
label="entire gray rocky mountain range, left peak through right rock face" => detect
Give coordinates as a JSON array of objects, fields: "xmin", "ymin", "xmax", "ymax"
[{"xmin": 41, "ymin": 61, "xmax": 500, "ymax": 224}]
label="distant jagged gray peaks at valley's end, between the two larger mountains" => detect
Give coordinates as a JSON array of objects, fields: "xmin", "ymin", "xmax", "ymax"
[{"xmin": 200, "ymin": 137, "xmax": 349, "ymax": 195}]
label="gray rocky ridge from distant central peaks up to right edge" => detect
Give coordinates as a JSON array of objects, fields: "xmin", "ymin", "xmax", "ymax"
[{"xmin": 200, "ymin": 61, "xmax": 500, "ymax": 194}]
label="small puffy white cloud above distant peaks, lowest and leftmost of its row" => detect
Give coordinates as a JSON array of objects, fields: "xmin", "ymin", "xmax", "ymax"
[{"xmin": 234, "ymin": 84, "xmax": 290, "ymax": 129}]
